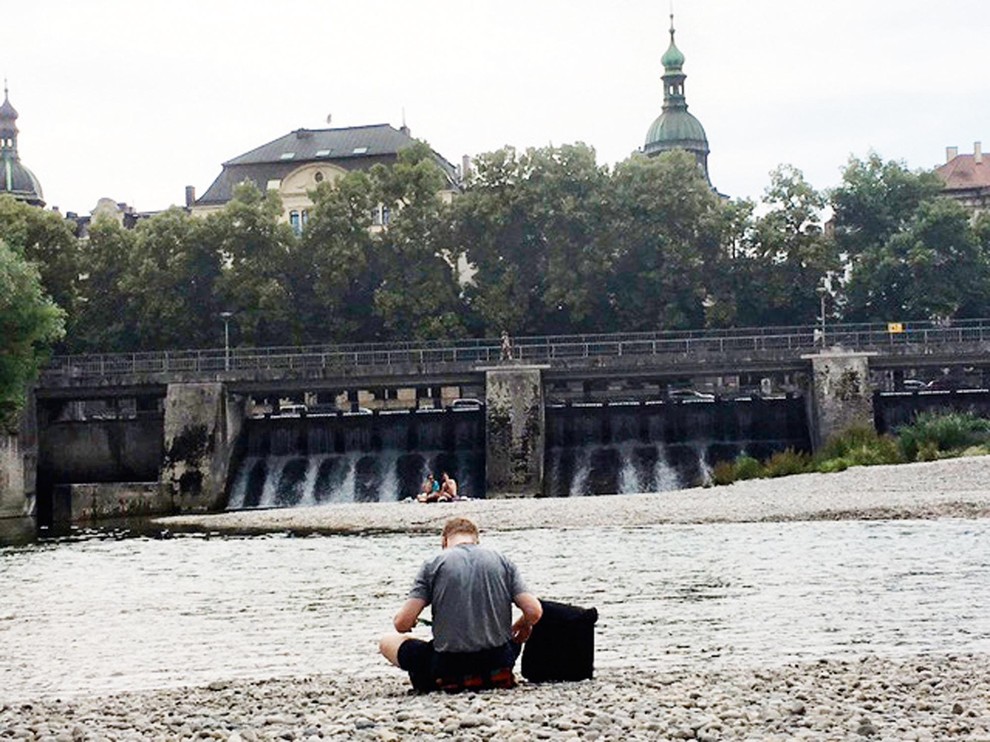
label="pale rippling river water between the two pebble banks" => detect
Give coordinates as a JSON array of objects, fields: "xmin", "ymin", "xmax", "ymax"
[{"xmin": 0, "ymin": 519, "xmax": 990, "ymax": 700}]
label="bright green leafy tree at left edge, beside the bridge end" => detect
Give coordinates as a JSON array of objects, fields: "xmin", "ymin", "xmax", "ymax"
[{"xmin": 0, "ymin": 240, "xmax": 65, "ymax": 429}]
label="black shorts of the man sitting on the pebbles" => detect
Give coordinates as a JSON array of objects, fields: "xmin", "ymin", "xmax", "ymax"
[{"xmin": 398, "ymin": 639, "xmax": 521, "ymax": 692}]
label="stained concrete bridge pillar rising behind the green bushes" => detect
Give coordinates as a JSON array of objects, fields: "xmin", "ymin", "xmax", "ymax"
[{"xmin": 801, "ymin": 351, "xmax": 876, "ymax": 451}]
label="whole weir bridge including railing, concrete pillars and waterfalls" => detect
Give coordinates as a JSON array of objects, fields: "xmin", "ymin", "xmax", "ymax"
[{"xmin": 0, "ymin": 320, "xmax": 990, "ymax": 519}]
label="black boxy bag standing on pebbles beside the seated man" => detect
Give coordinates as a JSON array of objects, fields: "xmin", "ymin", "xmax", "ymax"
[{"xmin": 521, "ymin": 600, "xmax": 598, "ymax": 683}]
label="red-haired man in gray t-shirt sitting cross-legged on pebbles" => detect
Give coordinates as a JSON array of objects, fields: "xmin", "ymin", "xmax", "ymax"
[{"xmin": 379, "ymin": 518, "xmax": 543, "ymax": 692}]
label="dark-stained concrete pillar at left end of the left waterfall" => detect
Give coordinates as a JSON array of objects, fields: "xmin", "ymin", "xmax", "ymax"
[{"xmin": 160, "ymin": 383, "xmax": 247, "ymax": 512}]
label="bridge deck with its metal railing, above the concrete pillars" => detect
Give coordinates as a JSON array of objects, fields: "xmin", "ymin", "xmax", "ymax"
[{"xmin": 38, "ymin": 319, "xmax": 990, "ymax": 397}]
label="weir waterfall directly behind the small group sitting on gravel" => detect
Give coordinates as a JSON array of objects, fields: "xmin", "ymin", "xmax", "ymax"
[{"xmin": 227, "ymin": 410, "xmax": 485, "ymax": 510}]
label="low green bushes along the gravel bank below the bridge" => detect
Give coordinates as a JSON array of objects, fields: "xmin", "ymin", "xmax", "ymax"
[{"xmin": 712, "ymin": 412, "xmax": 990, "ymax": 484}]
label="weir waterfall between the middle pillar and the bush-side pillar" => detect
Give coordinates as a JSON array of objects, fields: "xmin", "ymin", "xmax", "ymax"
[{"xmin": 545, "ymin": 398, "xmax": 810, "ymax": 497}]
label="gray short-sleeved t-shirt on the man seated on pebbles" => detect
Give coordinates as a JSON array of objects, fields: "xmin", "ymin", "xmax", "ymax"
[{"xmin": 409, "ymin": 544, "xmax": 529, "ymax": 652}]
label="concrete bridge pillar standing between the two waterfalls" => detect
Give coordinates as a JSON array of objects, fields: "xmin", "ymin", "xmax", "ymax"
[{"xmin": 483, "ymin": 365, "xmax": 548, "ymax": 497}]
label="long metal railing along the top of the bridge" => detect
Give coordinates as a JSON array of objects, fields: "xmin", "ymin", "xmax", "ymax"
[{"xmin": 41, "ymin": 319, "xmax": 990, "ymax": 385}]
